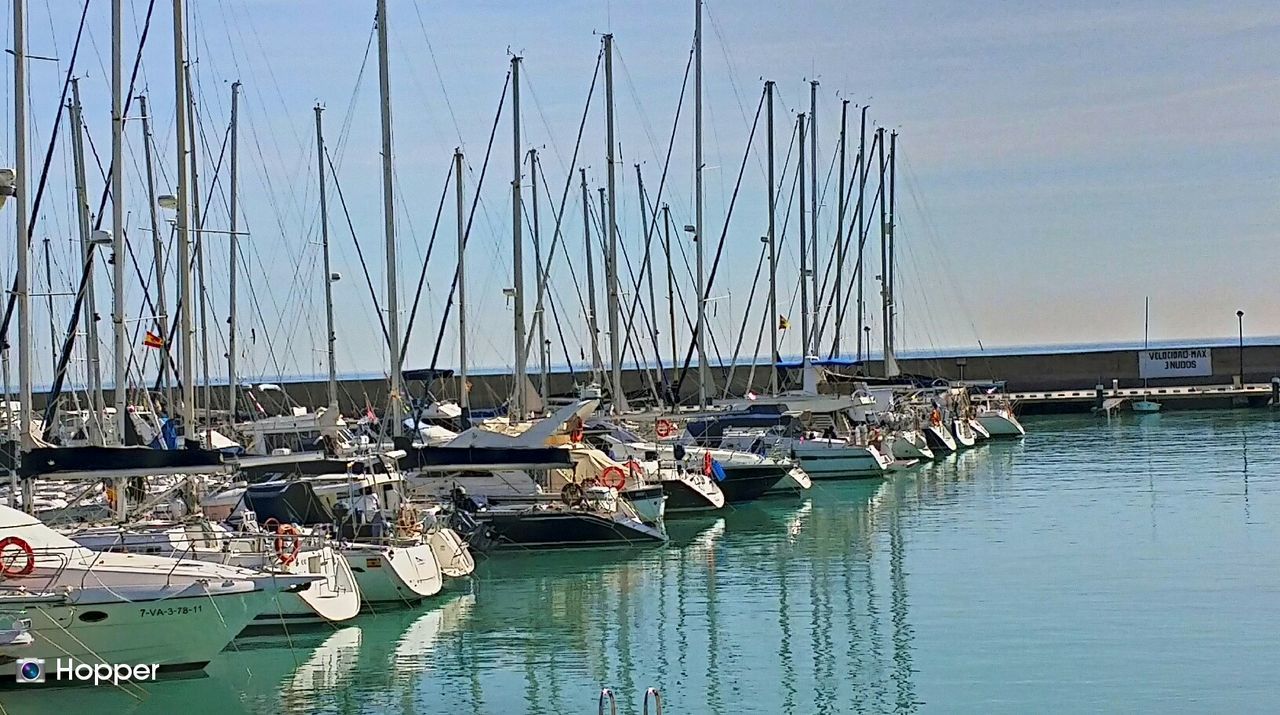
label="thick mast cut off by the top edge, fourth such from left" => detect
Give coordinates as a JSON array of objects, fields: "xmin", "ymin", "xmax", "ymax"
[{"xmin": 378, "ymin": 0, "xmax": 399, "ymax": 437}]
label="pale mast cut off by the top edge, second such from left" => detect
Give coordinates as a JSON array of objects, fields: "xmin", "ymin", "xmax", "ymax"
[{"xmin": 111, "ymin": 0, "xmax": 129, "ymax": 442}]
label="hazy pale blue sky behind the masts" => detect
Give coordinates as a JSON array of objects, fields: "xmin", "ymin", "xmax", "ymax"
[{"xmin": 0, "ymin": 0, "xmax": 1280, "ymax": 391}]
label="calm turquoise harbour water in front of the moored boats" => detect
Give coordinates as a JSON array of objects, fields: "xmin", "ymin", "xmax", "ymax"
[{"xmin": 0, "ymin": 411, "xmax": 1280, "ymax": 714}]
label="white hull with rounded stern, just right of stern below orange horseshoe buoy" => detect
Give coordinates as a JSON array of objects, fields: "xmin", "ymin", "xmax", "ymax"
[{"xmin": 340, "ymin": 544, "xmax": 444, "ymax": 605}]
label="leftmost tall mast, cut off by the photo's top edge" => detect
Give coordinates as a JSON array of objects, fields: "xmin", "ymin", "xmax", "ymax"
[{"xmin": 13, "ymin": 0, "xmax": 36, "ymax": 513}]
